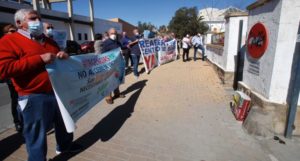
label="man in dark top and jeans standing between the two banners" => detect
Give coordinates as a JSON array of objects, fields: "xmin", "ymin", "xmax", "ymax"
[{"xmin": 128, "ymin": 29, "xmax": 141, "ymax": 79}]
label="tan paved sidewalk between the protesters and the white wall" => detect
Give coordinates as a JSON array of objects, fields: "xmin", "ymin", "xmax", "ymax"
[{"xmin": 0, "ymin": 57, "xmax": 300, "ymax": 161}]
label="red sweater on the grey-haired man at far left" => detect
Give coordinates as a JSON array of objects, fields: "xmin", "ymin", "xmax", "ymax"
[{"xmin": 0, "ymin": 32, "xmax": 59, "ymax": 96}]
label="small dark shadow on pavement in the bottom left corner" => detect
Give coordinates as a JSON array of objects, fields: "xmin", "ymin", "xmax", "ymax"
[{"xmin": 0, "ymin": 133, "xmax": 24, "ymax": 160}]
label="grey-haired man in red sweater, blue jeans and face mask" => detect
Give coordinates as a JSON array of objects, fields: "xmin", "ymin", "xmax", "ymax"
[{"xmin": 0, "ymin": 9, "xmax": 79, "ymax": 161}]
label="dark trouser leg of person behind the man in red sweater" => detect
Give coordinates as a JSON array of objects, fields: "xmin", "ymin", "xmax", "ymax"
[{"xmin": 6, "ymin": 80, "xmax": 22, "ymax": 124}]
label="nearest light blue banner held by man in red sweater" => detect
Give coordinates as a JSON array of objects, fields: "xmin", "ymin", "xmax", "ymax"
[{"xmin": 46, "ymin": 49, "xmax": 125, "ymax": 132}]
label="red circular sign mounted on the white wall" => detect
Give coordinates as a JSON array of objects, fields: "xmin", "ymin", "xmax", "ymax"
[{"xmin": 247, "ymin": 22, "xmax": 269, "ymax": 59}]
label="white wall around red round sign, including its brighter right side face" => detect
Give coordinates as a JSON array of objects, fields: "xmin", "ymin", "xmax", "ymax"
[{"xmin": 243, "ymin": 0, "xmax": 300, "ymax": 104}]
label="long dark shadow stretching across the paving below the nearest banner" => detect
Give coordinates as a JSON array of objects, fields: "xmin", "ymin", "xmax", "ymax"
[{"xmin": 51, "ymin": 80, "xmax": 147, "ymax": 161}]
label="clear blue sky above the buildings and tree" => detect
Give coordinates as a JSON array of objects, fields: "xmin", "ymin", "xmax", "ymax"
[{"xmin": 53, "ymin": 0, "xmax": 255, "ymax": 26}]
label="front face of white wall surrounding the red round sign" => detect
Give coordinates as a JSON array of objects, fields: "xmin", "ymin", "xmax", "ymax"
[{"xmin": 243, "ymin": 0, "xmax": 282, "ymax": 99}]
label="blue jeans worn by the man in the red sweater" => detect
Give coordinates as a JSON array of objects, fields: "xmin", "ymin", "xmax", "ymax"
[{"xmin": 18, "ymin": 94, "xmax": 73, "ymax": 161}]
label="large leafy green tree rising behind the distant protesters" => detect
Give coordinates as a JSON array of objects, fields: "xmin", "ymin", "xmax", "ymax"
[{"xmin": 168, "ymin": 7, "xmax": 208, "ymax": 38}]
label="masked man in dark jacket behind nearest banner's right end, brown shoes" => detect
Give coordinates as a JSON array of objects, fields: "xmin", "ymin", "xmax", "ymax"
[{"xmin": 101, "ymin": 28, "xmax": 125, "ymax": 104}]
